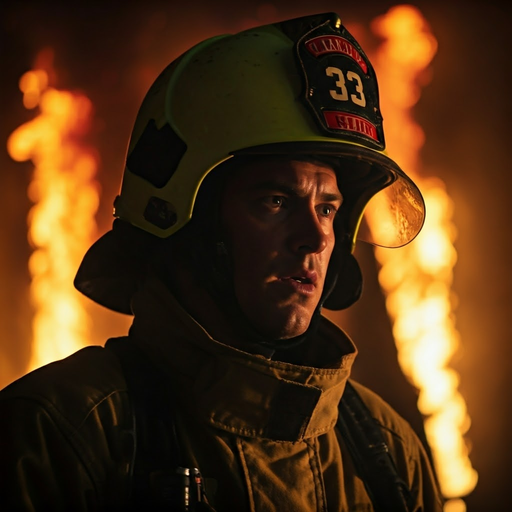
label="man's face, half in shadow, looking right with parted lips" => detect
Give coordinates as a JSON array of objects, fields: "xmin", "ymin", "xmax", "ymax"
[{"xmin": 222, "ymin": 160, "xmax": 342, "ymax": 339}]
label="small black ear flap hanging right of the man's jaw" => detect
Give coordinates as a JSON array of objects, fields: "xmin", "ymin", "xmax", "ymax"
[{"xmin": 323, "ymin": 251, "xmax": 363, "ymax": 311}]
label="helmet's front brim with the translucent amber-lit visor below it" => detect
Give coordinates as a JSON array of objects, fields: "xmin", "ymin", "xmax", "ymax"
[{"xmin": 234, "ymin": 141, "xmax": 425, "ymax": 248}]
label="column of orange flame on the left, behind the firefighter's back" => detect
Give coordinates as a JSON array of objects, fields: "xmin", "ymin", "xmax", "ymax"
[{"xmin": 7, "ymin": 61, "xmax": 99, "ymax": 371}]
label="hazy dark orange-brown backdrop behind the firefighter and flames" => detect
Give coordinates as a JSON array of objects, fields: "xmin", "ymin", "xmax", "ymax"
[{"xmin": 0, "ymin": 0, "xmax": 512, "ymax": 512}]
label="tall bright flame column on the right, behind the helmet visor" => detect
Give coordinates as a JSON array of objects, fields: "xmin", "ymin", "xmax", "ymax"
[{"xmin": 368, "ymin": 5, "xmax": 478, "ymax": 504}]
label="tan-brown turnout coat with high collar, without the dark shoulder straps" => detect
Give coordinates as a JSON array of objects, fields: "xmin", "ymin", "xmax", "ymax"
[{"xmin": 0, "ymin": 281, "xmax": 442, "ymax": 512}]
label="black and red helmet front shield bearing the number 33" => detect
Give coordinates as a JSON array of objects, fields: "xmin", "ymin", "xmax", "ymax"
[{"xmin": 292, "ymin": 15, "xmax": 385, "ymax": 150}]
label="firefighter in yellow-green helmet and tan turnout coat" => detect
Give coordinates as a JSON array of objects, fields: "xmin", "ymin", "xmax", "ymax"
[{"xmin": 0, "ymin": 13, "xmax": 442, "ymax": 512}]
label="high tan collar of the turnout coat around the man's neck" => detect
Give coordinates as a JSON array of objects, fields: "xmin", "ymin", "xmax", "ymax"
[{"xmin": 130, "ymin": 280, "xmax": 357, "ymax": 442}]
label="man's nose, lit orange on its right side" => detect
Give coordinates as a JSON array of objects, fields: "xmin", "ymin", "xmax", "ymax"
[{"xmin": 289, "ymin": 210, "xmax": 329, "ymax": 254}]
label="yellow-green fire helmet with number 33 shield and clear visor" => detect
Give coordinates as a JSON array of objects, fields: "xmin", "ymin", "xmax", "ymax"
[{"xmin": 75, "ymin": 13, "xmax": 424, "ymax": 310}]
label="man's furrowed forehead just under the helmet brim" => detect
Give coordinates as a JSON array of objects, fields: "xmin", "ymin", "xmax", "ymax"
[{"xmin": 226, "ymin": 158, "xmax": 339, "ymax": 194}]
